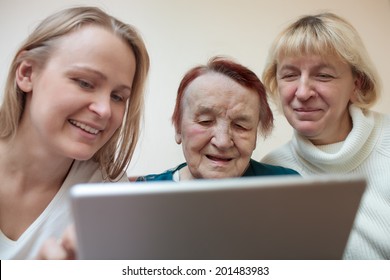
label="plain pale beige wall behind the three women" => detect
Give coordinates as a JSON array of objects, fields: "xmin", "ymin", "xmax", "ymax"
[{"xmin": 0, "ymin": 0, "xmax": 390, "ymax": 175}]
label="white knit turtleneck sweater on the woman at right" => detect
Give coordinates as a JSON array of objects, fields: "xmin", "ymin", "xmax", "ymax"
[{"xmin": 262, "ymin": 105, "xmax": 390, "ymax": 259}]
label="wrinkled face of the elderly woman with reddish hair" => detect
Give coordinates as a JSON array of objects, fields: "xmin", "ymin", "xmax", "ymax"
[{"xmin": 176, "ymin": 73, "xmax": 260, "ymax": 180}]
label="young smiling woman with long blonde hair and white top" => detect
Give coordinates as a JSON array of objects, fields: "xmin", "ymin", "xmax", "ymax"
[{"xmin": 0, "ymin": 7, "xmax": 149, "ymax": 259}]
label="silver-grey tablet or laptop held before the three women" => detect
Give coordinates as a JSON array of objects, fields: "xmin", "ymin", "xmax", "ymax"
[{"xmin": 70, "ymin": 175, "xmax": 366, "ymax": 260}]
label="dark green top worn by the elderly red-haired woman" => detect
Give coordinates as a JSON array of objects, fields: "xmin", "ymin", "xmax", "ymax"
[{"xmin": 137, "ymin": 159, "xmax": 299, "ymax": 181}]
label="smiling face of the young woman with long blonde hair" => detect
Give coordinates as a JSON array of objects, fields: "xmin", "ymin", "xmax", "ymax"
[{"xmin": 18, "ymin": 26, "xmax": 136, "ymax": 160}]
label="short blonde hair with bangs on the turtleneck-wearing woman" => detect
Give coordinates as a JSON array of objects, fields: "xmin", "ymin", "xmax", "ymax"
[{"xmin": 262, "ymin": 13, "xmax": 381, "ymax": 108}]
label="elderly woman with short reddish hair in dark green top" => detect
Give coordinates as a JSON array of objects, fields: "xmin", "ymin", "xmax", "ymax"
[{"xmin": 138, "ymin": 57, "xmax": 297, "ymax": 181}]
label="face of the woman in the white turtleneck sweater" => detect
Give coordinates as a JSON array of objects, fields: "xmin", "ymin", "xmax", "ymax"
[{"xmin": 276, "ymin": 55, "xmax": 358, "ymax": 145}]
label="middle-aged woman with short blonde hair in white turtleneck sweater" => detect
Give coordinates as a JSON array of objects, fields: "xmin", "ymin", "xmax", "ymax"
[{"xmin": 263, "ymin": 13, "xmax": 390, "ymax": 259}]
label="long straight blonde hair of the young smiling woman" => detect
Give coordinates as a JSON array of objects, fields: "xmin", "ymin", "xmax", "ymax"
[{"xmin": 0, "ymin": 7, "xmax": 149, "ymax": 180}]
